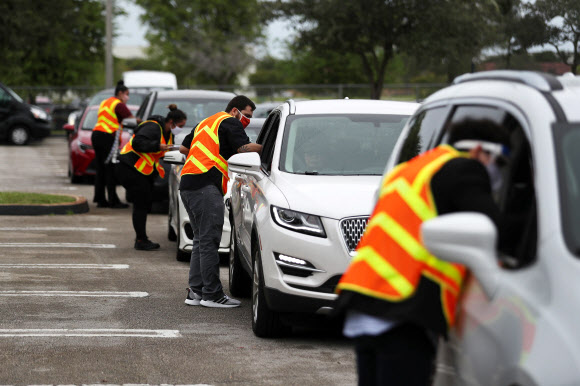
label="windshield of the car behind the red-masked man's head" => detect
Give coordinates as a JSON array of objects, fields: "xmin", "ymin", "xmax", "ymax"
[{"xmin": 151, "ymin": 99, "xmax": 230, "ymax": 127}]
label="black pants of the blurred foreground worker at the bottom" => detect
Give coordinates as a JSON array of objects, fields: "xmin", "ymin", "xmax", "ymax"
[{"xmin": 355, "ymin": 324, "xmax": 436, "ymax": 386}]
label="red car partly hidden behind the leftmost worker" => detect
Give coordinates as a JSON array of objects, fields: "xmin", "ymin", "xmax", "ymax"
[{"xmin": 63, "ymin": 105, "xmax": 139, "ymax": 183}]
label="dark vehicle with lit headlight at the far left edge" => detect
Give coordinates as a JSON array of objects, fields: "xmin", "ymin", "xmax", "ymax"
[{"xmin": 0, "ymin": 83, "xmax": 51, "ymax": 145}]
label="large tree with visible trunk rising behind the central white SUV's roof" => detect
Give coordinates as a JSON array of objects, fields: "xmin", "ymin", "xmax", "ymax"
[{"xmin": 269, "ymin": 0, "xmax": 429, "ymax": 99}]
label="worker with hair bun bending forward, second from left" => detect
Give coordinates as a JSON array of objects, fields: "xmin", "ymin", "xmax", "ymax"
[{"xmin": 115, "ymin": 104, "xmax": 187, "ymax": 251}]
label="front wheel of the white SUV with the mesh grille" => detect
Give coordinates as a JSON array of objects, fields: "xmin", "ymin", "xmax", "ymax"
[{"xmin": 252, "ymin": 244, "xmax": 285, "ymax": 338}]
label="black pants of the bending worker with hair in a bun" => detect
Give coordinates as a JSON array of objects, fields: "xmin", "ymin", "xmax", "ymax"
[{"xmin": 115, "ymin": 162, "xmax": 155, "ymax": 240}]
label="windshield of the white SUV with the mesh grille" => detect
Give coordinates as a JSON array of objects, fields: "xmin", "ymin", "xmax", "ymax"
[{"xmin": 280, "ymin": 114, "xmax": 409, "ymax": 175}]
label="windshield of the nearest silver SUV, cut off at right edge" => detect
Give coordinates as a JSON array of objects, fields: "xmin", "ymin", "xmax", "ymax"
[{"xmin": 556, "ymin": 124, "xmax": 580, "ymax": 256}]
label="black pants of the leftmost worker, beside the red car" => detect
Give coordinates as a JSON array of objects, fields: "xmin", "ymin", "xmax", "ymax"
[{"xmin": 91, "ymin": 131, "xmax": 120, "ymax": 205}]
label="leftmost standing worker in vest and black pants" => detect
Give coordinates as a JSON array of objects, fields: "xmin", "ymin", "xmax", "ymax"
[{"xmin": 91, "ymin": 80, "xmax": 141, "ymax": 209}]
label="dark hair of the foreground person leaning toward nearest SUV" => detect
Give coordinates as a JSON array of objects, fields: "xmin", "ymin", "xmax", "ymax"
[{"xmin": 448, "ymin": 118, "xmax": 510, "ymax": 146}]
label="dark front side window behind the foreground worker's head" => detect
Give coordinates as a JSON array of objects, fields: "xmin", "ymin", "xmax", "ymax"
[{"xmin": 442, "ymin": 105, "xmax": 537, "ymax": 268}]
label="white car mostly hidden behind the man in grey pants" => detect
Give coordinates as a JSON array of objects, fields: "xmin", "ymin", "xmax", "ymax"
[{"xmin": 165, "ymin": 118, "xmax": 265, "ymax": 261}]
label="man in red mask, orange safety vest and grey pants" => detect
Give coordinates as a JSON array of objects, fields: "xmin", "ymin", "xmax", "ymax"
[{"xmin": 179, "ymin": 95, "xmax": 262, "ymax": 308}]
